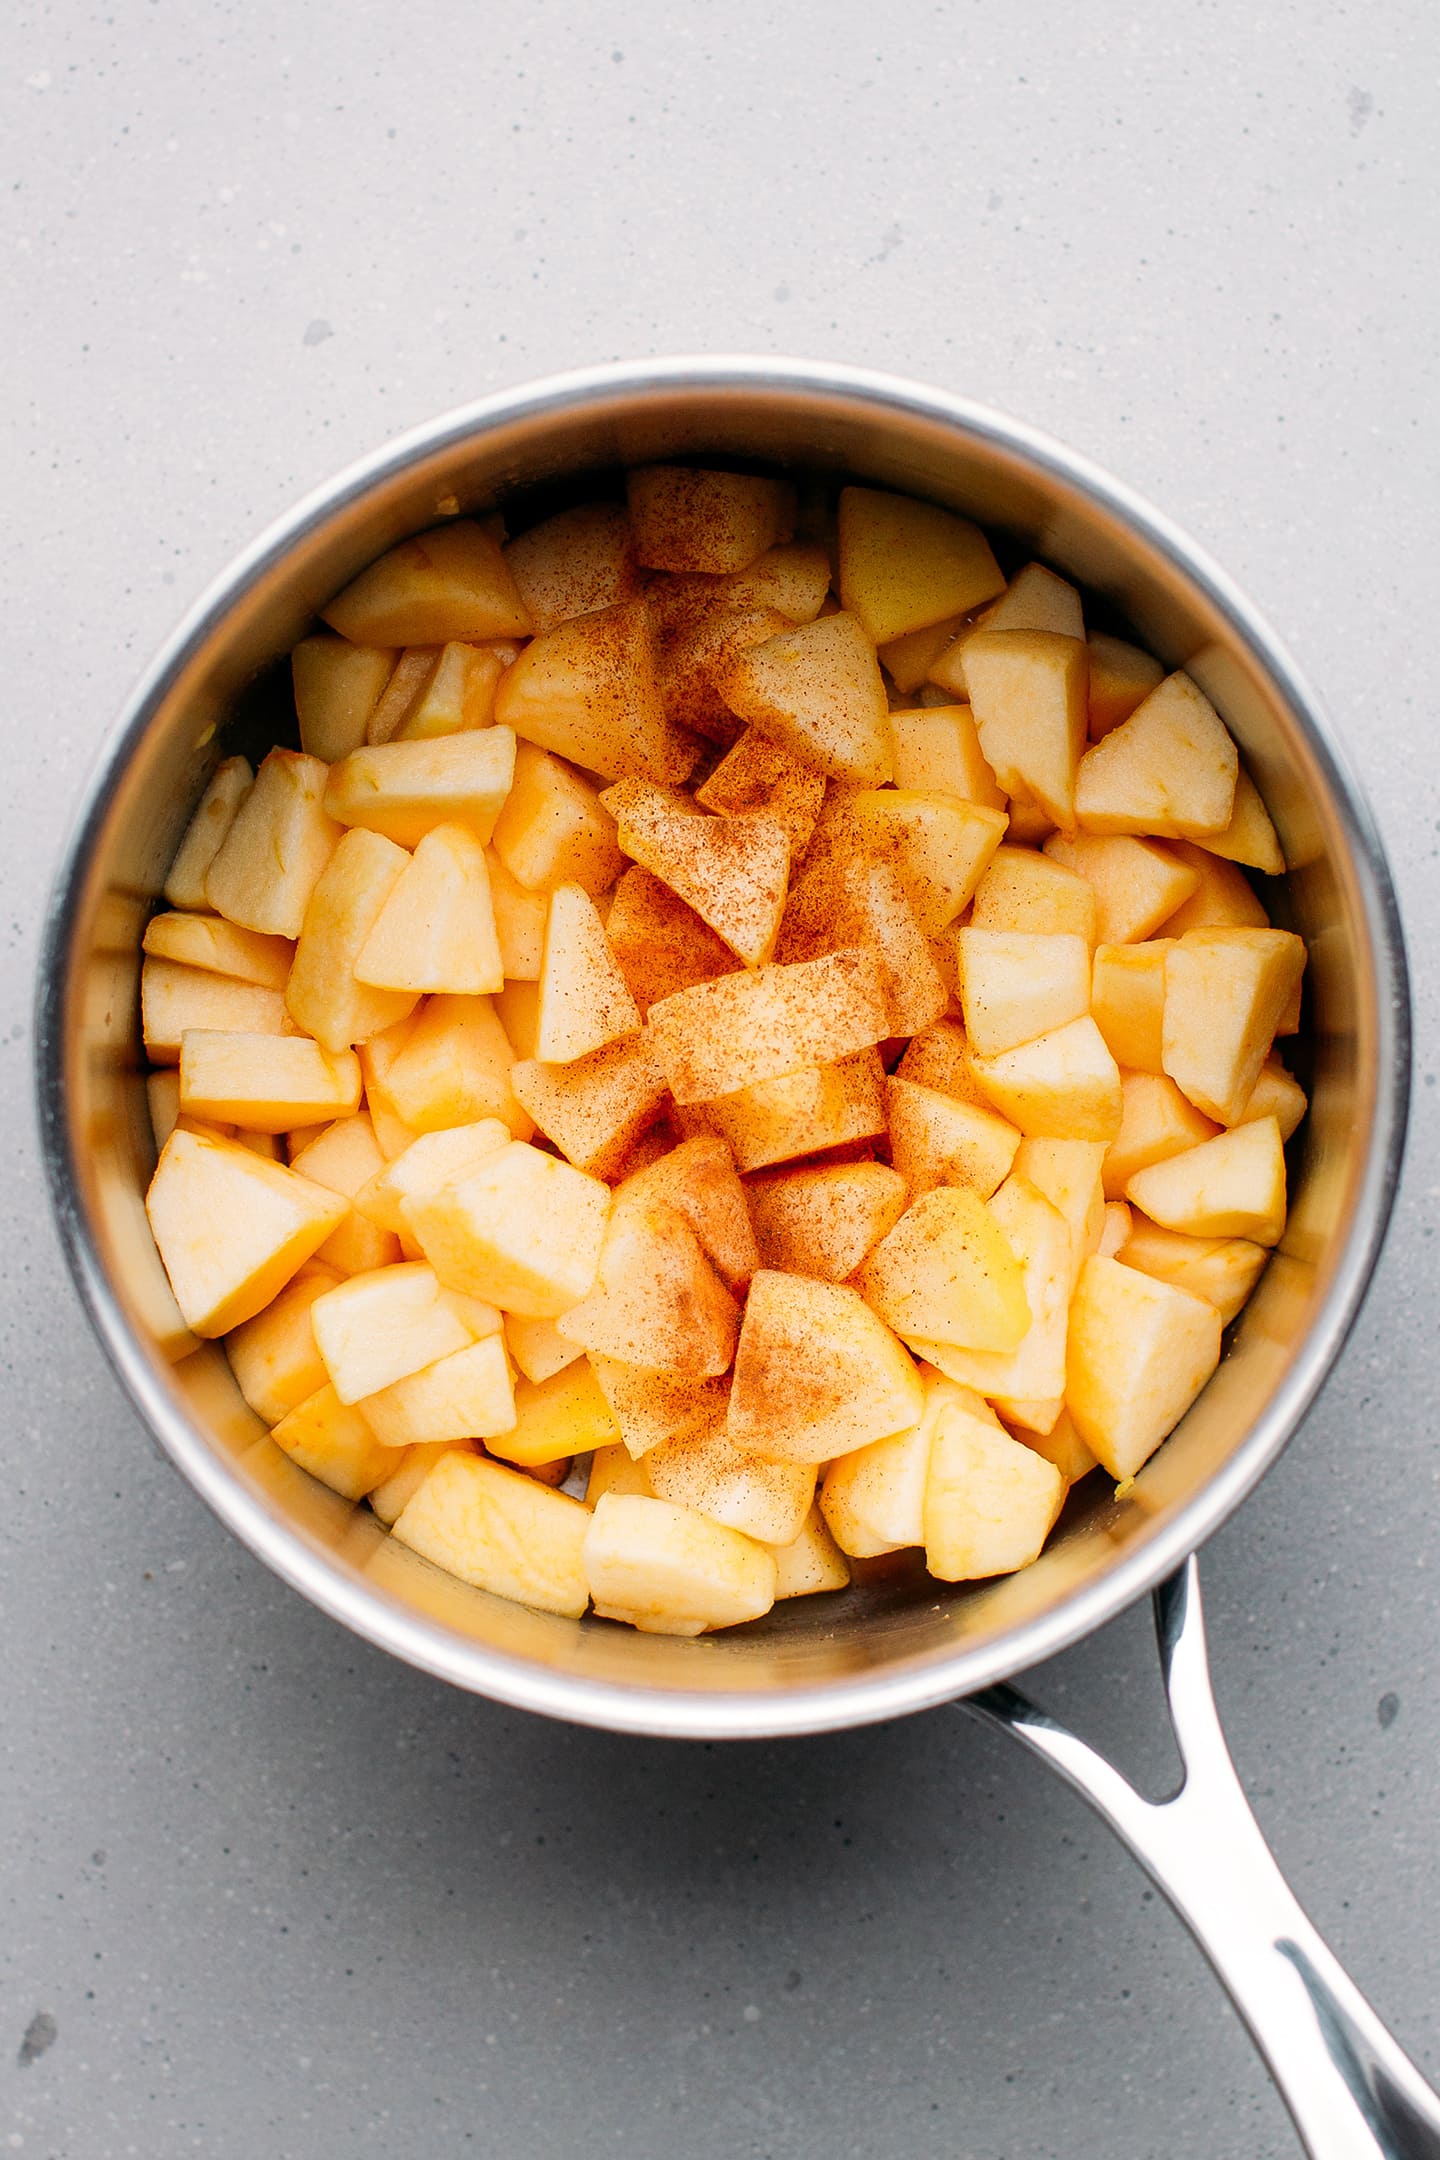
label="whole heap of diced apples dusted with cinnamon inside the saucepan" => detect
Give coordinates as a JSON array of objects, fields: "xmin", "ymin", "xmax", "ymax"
[{"xmin": 142, "ymin": 467, "xmax": 1304, "ymax": 1633}]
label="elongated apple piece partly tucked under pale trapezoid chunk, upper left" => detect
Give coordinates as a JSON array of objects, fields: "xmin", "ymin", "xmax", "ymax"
[{"xmin": 285, "ymin": 832, "xmax": 417, "ymax": 1050}]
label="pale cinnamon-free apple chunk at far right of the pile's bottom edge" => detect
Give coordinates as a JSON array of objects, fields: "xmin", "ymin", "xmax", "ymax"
[{"xmin": 924, "ymin": 1389, "xmax": 1067, "ymax": 1583}]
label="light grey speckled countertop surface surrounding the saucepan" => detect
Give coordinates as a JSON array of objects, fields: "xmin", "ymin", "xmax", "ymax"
[{"xmin": 0, "ymin": 0, "xmax": 1440, "ymax": 2160}]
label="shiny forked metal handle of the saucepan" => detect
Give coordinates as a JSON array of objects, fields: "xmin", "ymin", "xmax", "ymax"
[{"xmin": 963, "ymin": 1560, "xmax": 1440, "ymax": 2160}]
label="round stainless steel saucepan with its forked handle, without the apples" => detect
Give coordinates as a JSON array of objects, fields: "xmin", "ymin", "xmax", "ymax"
[{"xmin": 37, "ymin": 359, "xmax": 1440, "ymax": 2160}]
